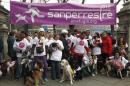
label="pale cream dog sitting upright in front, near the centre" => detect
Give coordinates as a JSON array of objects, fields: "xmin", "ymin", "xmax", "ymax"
[{"xmin": 60, "ymin": 59, "xmax": 75, "ymax": 84}]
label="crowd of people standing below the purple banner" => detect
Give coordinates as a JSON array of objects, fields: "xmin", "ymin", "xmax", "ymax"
[{"xmin": 0, "ymin": 28, "xmax": 130, "ymax": 84}]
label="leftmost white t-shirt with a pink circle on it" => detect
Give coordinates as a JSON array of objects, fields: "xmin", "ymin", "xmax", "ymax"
[{"xmin": 13, "ymin": 38, "xmax": 31, "ymax": 57}]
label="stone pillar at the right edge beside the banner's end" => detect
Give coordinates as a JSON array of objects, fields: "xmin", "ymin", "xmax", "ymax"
[{"xmin": 117, "ymin": 0, "xmax": 130, "ymax": 56}]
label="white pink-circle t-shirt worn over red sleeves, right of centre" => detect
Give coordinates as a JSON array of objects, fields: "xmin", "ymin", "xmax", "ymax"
[{"xmin": 74, "ymin": 38, "xmax": 88, "ymax": 54}]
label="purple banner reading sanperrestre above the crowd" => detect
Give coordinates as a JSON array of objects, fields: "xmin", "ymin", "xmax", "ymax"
[{"xmin": 10, "ymin": 1, "xmax": 116, "ymax": 25}]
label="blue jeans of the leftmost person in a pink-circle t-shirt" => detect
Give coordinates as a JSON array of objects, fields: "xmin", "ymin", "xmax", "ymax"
[{"xmin": 16, "ymin": 57, "xmax": 22, "ymax": 79}]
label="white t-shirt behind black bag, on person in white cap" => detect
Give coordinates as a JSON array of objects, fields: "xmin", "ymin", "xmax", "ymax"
[{"xmin": 33, "ymin": 37, "xmax": 46, "ymax": 56}]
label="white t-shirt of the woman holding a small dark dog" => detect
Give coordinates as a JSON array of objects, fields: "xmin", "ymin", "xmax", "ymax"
[{"xmin": 50, "ymin": 40, "xmax": 64, "ymax": 61}]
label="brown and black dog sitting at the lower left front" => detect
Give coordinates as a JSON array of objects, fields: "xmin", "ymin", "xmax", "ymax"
[{"xmin": 25, "ymin": 61, "xmax": 45, "ymax": 86}]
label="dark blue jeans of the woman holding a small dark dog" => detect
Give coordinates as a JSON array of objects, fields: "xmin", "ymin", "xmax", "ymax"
[{"xmin": 51, "ymin": 60, "xmax": 60, "ymax": 80}]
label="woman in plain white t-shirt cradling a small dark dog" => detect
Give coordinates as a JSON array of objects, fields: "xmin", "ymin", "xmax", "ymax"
[{"xmin": 49, "ymin": 34, "xmax": 64, "ymax": 80}]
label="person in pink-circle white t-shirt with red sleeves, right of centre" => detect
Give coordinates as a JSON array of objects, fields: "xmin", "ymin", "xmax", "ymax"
[{"xmin": 74, "ymin": 32, "xmax": 89, "ymax": 80}]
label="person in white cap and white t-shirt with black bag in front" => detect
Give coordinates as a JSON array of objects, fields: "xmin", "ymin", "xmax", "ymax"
[{"xmin": 32, "ymin": 28, "xmax": 48, "ymax": 81}]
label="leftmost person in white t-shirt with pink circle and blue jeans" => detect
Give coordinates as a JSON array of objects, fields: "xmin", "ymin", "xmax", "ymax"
[{"xmin": 13, "ymin": 33, "xmax": 31, "ymax": 79}]
